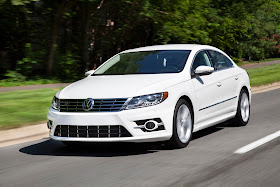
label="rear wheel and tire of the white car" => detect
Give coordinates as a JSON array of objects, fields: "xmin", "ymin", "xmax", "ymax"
[{"xmin": 232, "ymin": 89, "xmax": 251, "ymax": 126}]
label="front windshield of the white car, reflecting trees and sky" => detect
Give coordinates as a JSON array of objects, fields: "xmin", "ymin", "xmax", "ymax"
[{"xmin": 93, "ymin": 50, "xmax": 191, "ymax": 76}]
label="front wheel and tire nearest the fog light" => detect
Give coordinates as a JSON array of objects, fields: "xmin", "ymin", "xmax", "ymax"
[{"xmin": 168, "ymin": 99, "xmax": 193, "ymax": 149}]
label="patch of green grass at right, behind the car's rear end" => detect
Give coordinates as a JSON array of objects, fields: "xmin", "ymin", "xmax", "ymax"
[{"xmin": 247, "ymin": 64, "xmax": 280, "ymax": 86}]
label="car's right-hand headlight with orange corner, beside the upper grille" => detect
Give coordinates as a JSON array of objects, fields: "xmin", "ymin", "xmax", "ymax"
[{"xmin": 125, "ymin": 92, "xmax": 168, "ymax": 109}]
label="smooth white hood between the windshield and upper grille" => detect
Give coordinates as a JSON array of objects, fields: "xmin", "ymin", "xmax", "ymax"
[{"xmin": 56, "ymin": 73, "xmax": 183, "ymax": 99}]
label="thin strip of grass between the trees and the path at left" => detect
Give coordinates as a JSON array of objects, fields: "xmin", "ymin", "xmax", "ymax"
[{"xmin": 0, "ymin": 79, "xmax": 61, "ymax": 87}]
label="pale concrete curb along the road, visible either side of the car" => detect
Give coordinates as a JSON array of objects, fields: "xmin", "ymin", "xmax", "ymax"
[{"xmin": 0, "ymin": 82, "xmax": 280, "ymax": 147}]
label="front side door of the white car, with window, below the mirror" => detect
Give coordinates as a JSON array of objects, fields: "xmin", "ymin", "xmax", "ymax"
[{"xmin": 191, "ymin": 50, "xmax": 223, "ymax": 124}]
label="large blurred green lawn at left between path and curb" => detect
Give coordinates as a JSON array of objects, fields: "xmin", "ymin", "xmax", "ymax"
[{"xmin": 0, "ymin": 89, "xmax": 59, "ymax": 130}]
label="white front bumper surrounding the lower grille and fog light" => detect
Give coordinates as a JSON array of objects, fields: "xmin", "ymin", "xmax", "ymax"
[{"xmin": 48, "ymin": 101, "xmax": 174, "ymax": 142}]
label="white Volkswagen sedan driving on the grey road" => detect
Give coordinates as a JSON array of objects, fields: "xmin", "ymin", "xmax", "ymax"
[{"xmin": 48, "ymin": 44, "xmax": 251, "ymax": 148}]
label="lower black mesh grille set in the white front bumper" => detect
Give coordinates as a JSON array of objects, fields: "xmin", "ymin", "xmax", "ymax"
[{"xmin": 54, "ymin": 125, "xmax": 132, "ymax": 138}]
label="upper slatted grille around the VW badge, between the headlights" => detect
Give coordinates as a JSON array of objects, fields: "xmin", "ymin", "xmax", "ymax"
[{"xmin": 58, "ymin": 98, "xmax": 127, "ymax": 112}]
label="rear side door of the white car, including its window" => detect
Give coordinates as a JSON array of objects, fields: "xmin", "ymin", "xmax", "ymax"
[{"xmin": 209, "ymin": 50, "xmax": 238, "ymax": 115}]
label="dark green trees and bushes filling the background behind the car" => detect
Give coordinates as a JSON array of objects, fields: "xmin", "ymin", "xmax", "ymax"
[{"xmin": 0, "ymin": 0, "xmax": 280, "ymax": 79}]
